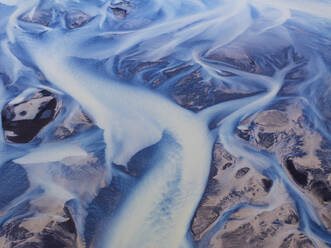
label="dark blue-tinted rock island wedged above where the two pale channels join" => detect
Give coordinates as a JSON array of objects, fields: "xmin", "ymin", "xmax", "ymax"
[{"xmin": 116, "ymin": 58, "xmax": 258, "ymax": 112}]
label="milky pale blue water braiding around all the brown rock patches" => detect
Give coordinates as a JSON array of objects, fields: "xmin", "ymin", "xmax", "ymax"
[{"xmin": 0, "ymin": 0, "xmax": 331, "ymax": 248}]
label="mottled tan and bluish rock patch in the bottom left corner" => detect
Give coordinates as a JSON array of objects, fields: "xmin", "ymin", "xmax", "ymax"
[{"xmin": 0, "ymin": 154, "xmax": 106, "ymax": 248}]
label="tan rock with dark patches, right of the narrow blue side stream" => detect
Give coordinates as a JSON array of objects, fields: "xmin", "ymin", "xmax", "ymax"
[{"xmin": 238, "ymin": 101, "xmax": 331, "ymax": 231}]
